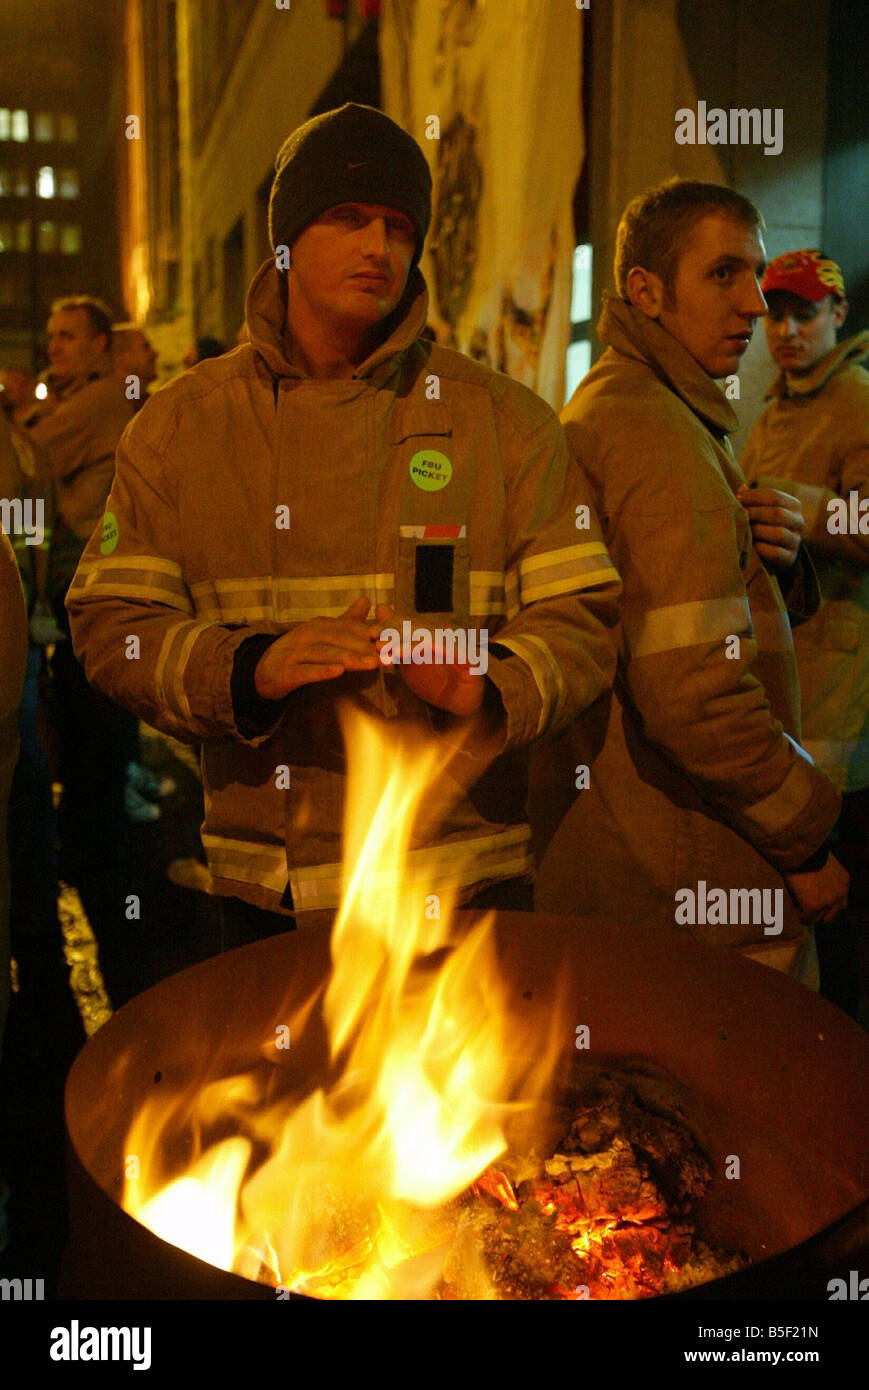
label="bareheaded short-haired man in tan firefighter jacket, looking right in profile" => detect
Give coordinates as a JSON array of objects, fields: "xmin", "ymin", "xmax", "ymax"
[{"xmin": 531, "ymin": 179, "xmax": 847, "ymax": 977}]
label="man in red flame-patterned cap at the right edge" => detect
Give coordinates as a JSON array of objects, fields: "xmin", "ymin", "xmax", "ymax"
[{"xmin": 741, "ymin": 250, "xmax": 869, "ymax": 1012}]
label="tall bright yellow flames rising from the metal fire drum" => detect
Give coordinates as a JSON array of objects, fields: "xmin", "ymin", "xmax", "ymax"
[{"xmin": 122, "ymin": 712, "xmax": 566, "ymax": 1300}]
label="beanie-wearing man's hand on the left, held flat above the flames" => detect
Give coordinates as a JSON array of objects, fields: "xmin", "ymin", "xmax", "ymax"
[{"xmin": 254, "ymin": 595, "xmax": 381, "ymax": 699}]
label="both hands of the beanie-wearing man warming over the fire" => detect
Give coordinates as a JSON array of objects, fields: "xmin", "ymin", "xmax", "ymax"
[{"xmin": 254, "ymin": 595, "xmax": 487, "ymax": 717}]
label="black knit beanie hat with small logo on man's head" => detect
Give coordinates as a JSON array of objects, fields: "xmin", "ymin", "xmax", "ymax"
[{"xmin": 268, "ymin": 101, "xmax": 431, "ymax": 265}]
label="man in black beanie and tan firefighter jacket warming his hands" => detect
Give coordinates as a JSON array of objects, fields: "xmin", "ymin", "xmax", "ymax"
[{"xmin": 68, "ymin": 104, "xmax": 619, "ymax": 941}]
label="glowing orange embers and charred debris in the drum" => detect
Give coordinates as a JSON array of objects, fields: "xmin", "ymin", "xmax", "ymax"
[{"xmin": 442, "ymin": 1072, "xmax": 747, "ymax": 1300}]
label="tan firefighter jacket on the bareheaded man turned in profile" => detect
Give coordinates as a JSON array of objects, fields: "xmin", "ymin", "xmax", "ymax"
[{"xmin": 531, "ymin": 300, "xmax": 838, "ymax": 956}]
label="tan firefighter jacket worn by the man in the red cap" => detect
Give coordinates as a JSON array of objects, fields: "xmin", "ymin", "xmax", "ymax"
[{"xmin": 740, "ymin": 331, "xmax": 869, "ymax": 792}]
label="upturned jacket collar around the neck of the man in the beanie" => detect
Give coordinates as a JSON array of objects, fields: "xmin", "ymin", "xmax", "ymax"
[{"xmin": 245, "ymin": 257, "xmax": 428, "ymax": 386}]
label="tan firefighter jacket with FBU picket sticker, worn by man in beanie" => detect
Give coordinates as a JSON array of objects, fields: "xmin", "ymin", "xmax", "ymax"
[{"xmin": 68, "ymin": 261, "xmax": 620, "ymax": 913}]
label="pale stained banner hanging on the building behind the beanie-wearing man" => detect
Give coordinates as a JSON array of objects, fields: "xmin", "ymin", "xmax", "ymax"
[{"xmin": 380, "ymin": 0, "xmax": 584, "ymax": 410}]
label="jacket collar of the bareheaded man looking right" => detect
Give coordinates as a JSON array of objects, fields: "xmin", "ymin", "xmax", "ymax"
[{"xmin": 598, "ymin": 293, "xmax": 738, "ymax": 434}]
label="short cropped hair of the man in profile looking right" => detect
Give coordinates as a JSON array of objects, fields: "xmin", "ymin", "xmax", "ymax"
[{"xmin": 613, "ymin": 178, "xmax": 763, "ymax": 303}]
